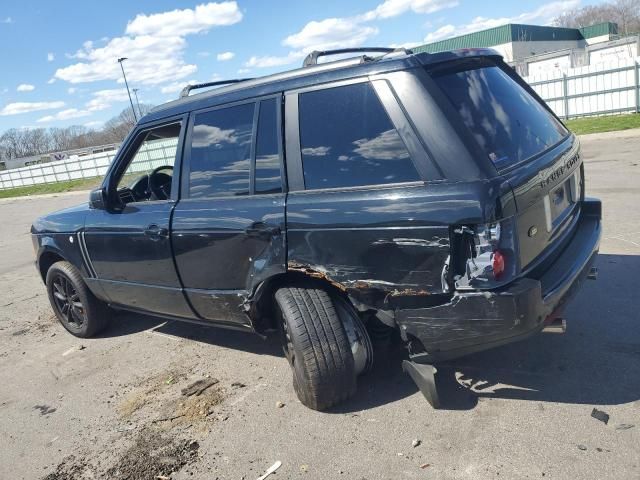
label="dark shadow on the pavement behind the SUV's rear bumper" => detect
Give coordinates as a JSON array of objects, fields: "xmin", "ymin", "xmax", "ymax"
[{"xmin": 438, "ymin": 254, "xmax": 640, "ymax": 409}]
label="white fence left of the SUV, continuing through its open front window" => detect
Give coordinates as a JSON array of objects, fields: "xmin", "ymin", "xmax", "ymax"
[{"xmin": 0, "ymin": 139, "xmax": 178, "ymax": 190}]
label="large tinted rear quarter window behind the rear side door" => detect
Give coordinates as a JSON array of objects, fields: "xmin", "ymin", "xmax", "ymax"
[{"xmin": 299, "ymin": 83, "xmax": 420, "ymax": 189}]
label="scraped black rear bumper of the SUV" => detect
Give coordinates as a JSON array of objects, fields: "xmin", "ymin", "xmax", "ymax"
[{"xmin": 396, "ymin": 200, "xmax": 602, "ymax": 363}]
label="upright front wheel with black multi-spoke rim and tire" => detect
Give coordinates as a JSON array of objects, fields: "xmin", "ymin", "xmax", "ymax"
[{"xmin": 46, "ymin": 262, "xmax": 109, "ymax": 338}]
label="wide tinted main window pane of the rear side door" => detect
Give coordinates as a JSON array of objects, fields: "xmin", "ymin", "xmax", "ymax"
[{"xmin": 189, "ymin": 103, "xmax": 255, "ymax": 198}]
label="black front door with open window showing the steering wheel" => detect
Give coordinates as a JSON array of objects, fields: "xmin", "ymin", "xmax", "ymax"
[{"xmin": 83, "ymin": 118, "xmax": 194, "ymax": 318}]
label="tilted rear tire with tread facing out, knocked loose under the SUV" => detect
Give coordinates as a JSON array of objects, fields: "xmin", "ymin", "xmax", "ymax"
[{"xmin": 275, "ymin": 287, "xmax": 356, "ymax": 410}]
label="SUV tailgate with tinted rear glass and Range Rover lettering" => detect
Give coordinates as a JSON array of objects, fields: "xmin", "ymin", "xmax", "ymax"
[{"xmin": 429, "ymin": 57, "xmax": 583, "ymax": 270}]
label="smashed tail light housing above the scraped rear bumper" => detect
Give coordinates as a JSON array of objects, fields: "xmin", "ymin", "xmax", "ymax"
[{"xmin": 452, "ymin": 218, "xmax": 517, "ymax": 290}]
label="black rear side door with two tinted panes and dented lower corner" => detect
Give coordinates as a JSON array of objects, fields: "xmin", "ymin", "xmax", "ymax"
[{"xmin": 171, "ymin": 95, "xmax": 286, "ymax": 328}]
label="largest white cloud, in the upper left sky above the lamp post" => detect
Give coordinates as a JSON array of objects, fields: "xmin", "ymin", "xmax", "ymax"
[{"xmin": 55, "ymin": 2, "xmax": 242, "ymax": 85}]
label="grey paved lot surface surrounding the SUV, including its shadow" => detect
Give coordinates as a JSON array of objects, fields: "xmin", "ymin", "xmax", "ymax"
[{"xmin": 0, "ymin": 130, "xmax": 640, "ymax": 480}]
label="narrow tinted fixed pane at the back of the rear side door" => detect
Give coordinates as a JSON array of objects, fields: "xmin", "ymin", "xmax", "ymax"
[{"xmin": 255, "ymin": 98, "xmax": 282, "ymax": 193}]
